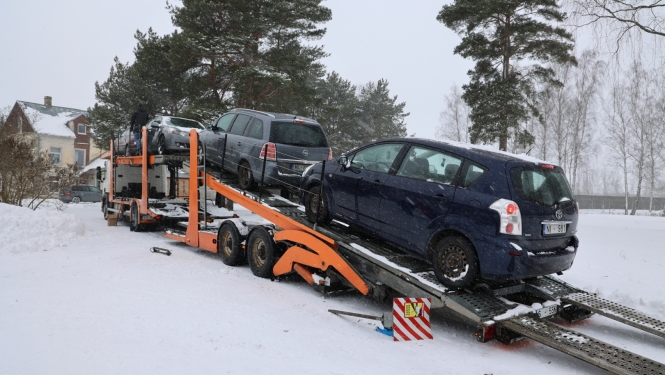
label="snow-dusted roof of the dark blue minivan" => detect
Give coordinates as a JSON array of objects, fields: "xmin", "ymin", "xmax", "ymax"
[{"xmin": 364, "ymin": 138, "xmax": 556, "ymax": 165}]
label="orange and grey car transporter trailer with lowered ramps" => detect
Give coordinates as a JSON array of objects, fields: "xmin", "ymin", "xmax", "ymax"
[{"xmin": 103, "ymin": 128, "xmax": 665, "ymax": 375}]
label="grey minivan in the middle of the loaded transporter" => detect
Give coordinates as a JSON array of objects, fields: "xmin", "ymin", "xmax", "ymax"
[{"xmin": 199, "ymin": 109, "xmax": 332, "ymax": 194}]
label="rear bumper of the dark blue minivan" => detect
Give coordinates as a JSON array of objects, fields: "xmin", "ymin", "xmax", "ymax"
[{"xmin": 476, "ymin": 236, "xmax": 578, "ymax": 281}]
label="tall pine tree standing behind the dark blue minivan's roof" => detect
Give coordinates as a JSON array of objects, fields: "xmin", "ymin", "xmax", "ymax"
[{"xmin": 437, "ymin": 0, "xmax": 575, "ymax": 150}]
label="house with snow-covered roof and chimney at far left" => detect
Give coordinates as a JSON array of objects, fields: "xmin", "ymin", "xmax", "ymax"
[{"xmin": 5, "ymin": 96, "xmax": 102, "ymax": 167}]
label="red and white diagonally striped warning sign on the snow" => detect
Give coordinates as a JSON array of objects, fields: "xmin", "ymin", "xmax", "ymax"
[{"xmin": 393, "ymin": 298, "xmax": 433, "ymax": 341}]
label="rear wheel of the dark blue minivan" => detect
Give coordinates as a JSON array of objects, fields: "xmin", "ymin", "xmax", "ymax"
[{"xmin": 432, "ymin": 236, "xmax": 480, "ymax": 290}]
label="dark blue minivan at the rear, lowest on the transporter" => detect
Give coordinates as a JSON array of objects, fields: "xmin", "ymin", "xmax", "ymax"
[{"xmin": 300, "ymin": 138, "xmax": 579, "ymax": 289}]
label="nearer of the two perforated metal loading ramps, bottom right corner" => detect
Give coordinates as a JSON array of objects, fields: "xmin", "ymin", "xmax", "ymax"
[{"xmin": 501, "ymin": 316, "xmax": 665, "ymax": 375}]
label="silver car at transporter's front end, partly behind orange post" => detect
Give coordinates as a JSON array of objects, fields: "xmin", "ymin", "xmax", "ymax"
[{"xmin": 116, "ymin": 115, "xmax": 205, "ymax": 156}]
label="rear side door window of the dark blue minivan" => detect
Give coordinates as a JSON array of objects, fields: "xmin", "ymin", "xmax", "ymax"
[{"xmin": 397, "ymin": 146, "xmax": 462, "ymax": 185}]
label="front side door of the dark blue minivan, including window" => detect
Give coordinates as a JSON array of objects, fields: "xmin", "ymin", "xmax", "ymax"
[{"xmin": 329, "ymin": 142, "xmax": 404, "ymax": 229}]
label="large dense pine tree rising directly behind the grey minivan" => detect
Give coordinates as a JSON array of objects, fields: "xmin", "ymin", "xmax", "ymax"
[{"xmin": 169, "ymin": 0, "xmax": 332, "ymax": 112}]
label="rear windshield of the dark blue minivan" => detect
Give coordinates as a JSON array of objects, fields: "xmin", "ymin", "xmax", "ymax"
[{"xmin": 510, "ymin": 167, "xmax": 574, "ymax": 206}]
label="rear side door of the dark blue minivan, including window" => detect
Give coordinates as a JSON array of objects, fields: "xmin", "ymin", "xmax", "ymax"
[{"xmin": 380, "ymin": 145, "xmax": 462, "ymax": 252}]
